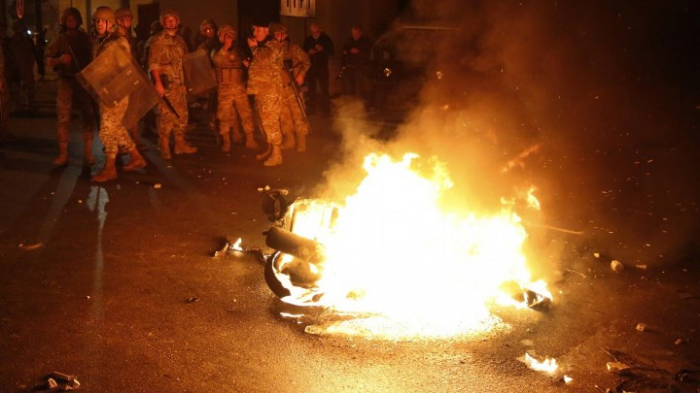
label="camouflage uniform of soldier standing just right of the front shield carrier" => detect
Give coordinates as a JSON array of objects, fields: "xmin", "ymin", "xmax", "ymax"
[{"xmin": 148, "ymin": 30, "xmax": 188, "ymax": 153}]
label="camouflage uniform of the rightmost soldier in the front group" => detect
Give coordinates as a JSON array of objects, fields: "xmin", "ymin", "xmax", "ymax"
[{"xmin": 281, "ymin": 40, "xmax": 311, "ymax": 151}]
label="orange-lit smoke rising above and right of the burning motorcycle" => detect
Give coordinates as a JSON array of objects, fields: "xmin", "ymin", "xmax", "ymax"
[{"xmin": 322, "ymin": 0, "xmax": 700, "ymax": 265}]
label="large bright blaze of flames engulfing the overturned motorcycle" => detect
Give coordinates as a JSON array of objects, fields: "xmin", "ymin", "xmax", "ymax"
[{"xmin": 274, "ymin": 154, "xmax": 551, "ymax": 337}]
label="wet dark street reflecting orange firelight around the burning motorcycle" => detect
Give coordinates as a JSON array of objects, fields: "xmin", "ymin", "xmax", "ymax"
[{"xmin": 0, "ymin": 78, "xmax": 700, "ymax": 392}]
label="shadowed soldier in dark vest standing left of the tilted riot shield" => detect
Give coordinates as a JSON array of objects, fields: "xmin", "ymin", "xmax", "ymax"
[{"xmin": 46, "ymin": 7, "xmax": 95, "ymax": 165}]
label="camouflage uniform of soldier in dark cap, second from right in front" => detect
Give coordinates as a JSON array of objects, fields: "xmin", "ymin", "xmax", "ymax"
[{"xmin": 248, "ymin": 39, "xmax": 283, "ymax": 165}]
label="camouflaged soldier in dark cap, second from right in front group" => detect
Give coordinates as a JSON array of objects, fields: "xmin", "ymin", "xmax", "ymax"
[{"xmin": 248, "ymin": 17, "xmax": 284, "ymax": 166}]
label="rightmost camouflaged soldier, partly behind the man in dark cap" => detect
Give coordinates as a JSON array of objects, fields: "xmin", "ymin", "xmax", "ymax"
[{"xmin": 270, "ymin": 23, "xmax": 311, "ymax": 152}]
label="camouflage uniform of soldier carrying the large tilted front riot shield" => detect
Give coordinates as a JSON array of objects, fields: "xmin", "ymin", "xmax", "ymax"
[{"xmin": 95, "ymin": 33, "xmax": 136, "ymax": 156}]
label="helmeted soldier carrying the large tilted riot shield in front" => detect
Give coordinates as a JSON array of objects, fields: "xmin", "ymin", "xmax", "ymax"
[{"xmin": 92, "ymin": 6, "xmax": 146, "ymax": 182}]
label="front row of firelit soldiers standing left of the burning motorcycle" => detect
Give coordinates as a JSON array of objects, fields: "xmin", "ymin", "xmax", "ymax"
[{"xmin": 36, "ymin": 6, "xmax": 311, "ymax": 182}]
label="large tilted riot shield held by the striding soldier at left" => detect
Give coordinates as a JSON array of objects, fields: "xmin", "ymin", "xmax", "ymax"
[{"xmin": 76, "ymin": 45, "xmax": 159, "ymax": 129}]
